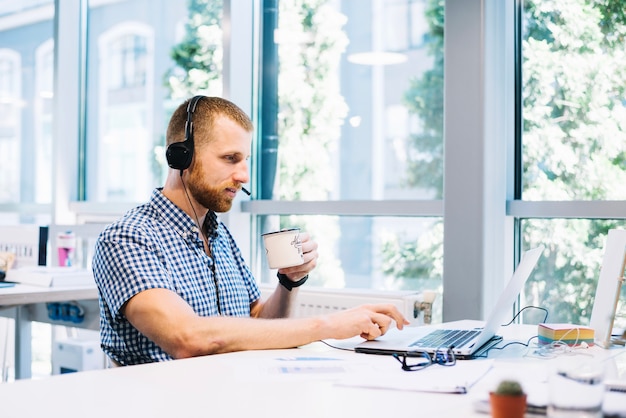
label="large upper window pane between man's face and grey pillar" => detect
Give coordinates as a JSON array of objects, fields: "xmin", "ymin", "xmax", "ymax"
[{"xmin": 259, "ymin": 0, "xmax": 443, "ymax": 200}]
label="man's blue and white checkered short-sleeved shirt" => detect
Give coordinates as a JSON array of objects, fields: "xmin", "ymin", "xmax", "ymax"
[{"xmin": 92, "ymin": 189, "xmax": 260, "ymax": 365}]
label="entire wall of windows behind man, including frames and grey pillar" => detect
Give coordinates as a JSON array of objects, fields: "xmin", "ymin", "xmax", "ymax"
[{"xmin": 0, "ymin": 0, "xmax": 626, "ymax": 330}]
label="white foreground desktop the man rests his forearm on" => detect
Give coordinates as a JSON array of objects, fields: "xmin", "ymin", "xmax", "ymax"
[{"xmin": 0, "ymin": 326, "xmax": 626, "ymax": 418}]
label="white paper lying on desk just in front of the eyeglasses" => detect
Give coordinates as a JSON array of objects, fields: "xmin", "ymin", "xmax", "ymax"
[{"xmin": 336, "ymin": 360, "xmax": 493, "ymax": 394}]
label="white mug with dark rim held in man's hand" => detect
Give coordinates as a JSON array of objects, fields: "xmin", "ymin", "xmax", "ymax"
[{"xmin": 262, "ymin": 228, "xmax": 304, "ymax": 269}]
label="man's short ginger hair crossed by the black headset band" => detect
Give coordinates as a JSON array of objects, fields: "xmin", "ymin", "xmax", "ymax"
[{"xmin": 166, "ymin": 96, "xmax": 254, "ymax": 145}]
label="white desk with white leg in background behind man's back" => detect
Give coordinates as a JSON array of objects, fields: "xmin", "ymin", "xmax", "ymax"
[{"xmin": 0, "ymin": 284, "xmax": 100, "ymax": 379}]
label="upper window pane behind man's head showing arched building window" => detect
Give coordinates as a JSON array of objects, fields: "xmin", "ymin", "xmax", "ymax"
[{"xmin": 82, "ymin": 0, "xmax": 217, "ymax": 202}]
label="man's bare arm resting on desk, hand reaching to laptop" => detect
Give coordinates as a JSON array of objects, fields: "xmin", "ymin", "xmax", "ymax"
[{"xmin": 122, "ymin": 289, "xmax": 408, "ymax": 358}]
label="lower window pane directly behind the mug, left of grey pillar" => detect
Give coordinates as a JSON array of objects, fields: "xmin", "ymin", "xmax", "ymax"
[{"xmin": 255, "ymin": 215, "xmax": 443, "ymax": 319}]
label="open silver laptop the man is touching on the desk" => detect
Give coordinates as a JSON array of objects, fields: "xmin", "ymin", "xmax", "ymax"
[{"xmin": 354, "ymin": 246, "xmax": 544, "ymax": 359}]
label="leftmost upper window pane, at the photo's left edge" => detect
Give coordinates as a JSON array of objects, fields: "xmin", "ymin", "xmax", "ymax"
[{"xmin": 0, "ymin": 0, "xmax": 54, "ymax": 212}]
